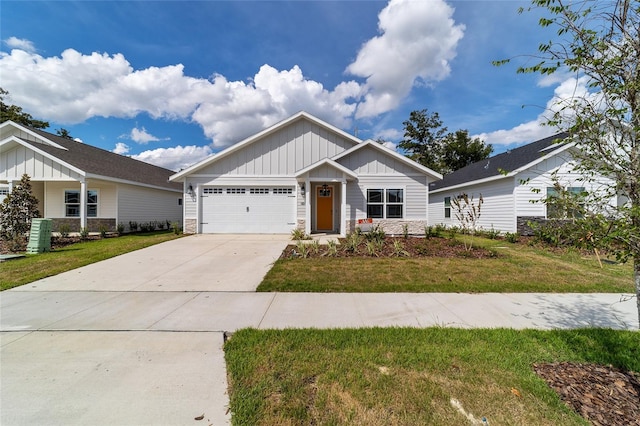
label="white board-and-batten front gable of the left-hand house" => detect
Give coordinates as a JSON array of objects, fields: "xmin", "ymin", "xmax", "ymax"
[{"xmin": 0, "ymin": 145, "xmax": 81, "ymax": 181}]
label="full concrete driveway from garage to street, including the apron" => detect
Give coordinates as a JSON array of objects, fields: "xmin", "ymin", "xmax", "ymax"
[{"xmin": 0, "ymin": 235, "xmax": 289, "ymax": 426}]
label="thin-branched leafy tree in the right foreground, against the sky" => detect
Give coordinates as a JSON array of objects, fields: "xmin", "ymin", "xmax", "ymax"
[{"xmin": 496, "ymin": 0, "xmax": 640, "ymax": 323}]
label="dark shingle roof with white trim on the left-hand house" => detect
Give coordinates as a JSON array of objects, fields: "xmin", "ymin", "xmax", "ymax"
[{"xmin": 3, "ymin": 122, "xmax": 182, "ymax": 191}]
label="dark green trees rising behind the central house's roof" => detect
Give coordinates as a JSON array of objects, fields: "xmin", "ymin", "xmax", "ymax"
[{"xmin": 398, "ymin": 109, "xmax": 493, "ymax": 174}]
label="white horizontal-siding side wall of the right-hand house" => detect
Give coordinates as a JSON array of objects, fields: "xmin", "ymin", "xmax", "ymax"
[{"xmin": 429, "ymin": 177, "xmax": 516, "ymax": 232}]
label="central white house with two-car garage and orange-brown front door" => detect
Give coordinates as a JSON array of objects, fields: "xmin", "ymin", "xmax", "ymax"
[{"xmin": 171, "ymin": 112, "xmax": 442, "ymax": 235}]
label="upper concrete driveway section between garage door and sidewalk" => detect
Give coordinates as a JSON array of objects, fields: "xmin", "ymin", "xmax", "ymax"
[{"xmin": 20, "ymin": 235, "xmax": 290, "ymax": 292}]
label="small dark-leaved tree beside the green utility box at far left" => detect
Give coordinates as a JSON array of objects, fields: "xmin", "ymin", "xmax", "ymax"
[{"xmin": 0, "ymin": 174, "xmax": 40, "ymax": 250}]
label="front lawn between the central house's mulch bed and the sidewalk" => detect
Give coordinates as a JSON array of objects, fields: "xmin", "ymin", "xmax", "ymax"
[{"xmin": 258, "ymin": 238, "xmax": 634, "ymax": 293}]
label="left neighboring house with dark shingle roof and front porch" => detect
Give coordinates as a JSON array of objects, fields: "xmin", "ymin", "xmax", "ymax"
[{"xmin": 0, "ymin": 121, "xmax": 182, "ymax": 232}]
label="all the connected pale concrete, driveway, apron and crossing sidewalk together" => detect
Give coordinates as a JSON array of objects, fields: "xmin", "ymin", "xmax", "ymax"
[{"xmin": 0, "ymin": 236, "xmax": 638, "ymax": 426}]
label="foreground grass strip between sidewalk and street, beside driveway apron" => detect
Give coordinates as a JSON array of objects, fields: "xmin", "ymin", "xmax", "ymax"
[{"xmin": 225, "ymin": 328, "xmax": 640, "ymax": 426}]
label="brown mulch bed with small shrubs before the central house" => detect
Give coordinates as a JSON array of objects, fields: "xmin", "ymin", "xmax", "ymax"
[{"xmin": 281, "ymin": 237, "xmax": 497, "ymax": 259}]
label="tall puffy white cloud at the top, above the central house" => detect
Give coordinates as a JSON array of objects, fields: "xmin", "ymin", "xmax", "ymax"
[{"xmin": 346, "ymin": 0, "xmax": 465, "ymax": 118}]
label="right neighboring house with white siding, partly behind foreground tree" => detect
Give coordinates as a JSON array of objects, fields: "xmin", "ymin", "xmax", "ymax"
[{"xmin": 429, "ymin": 134, "xmax": 618, "ymax": 234}]
